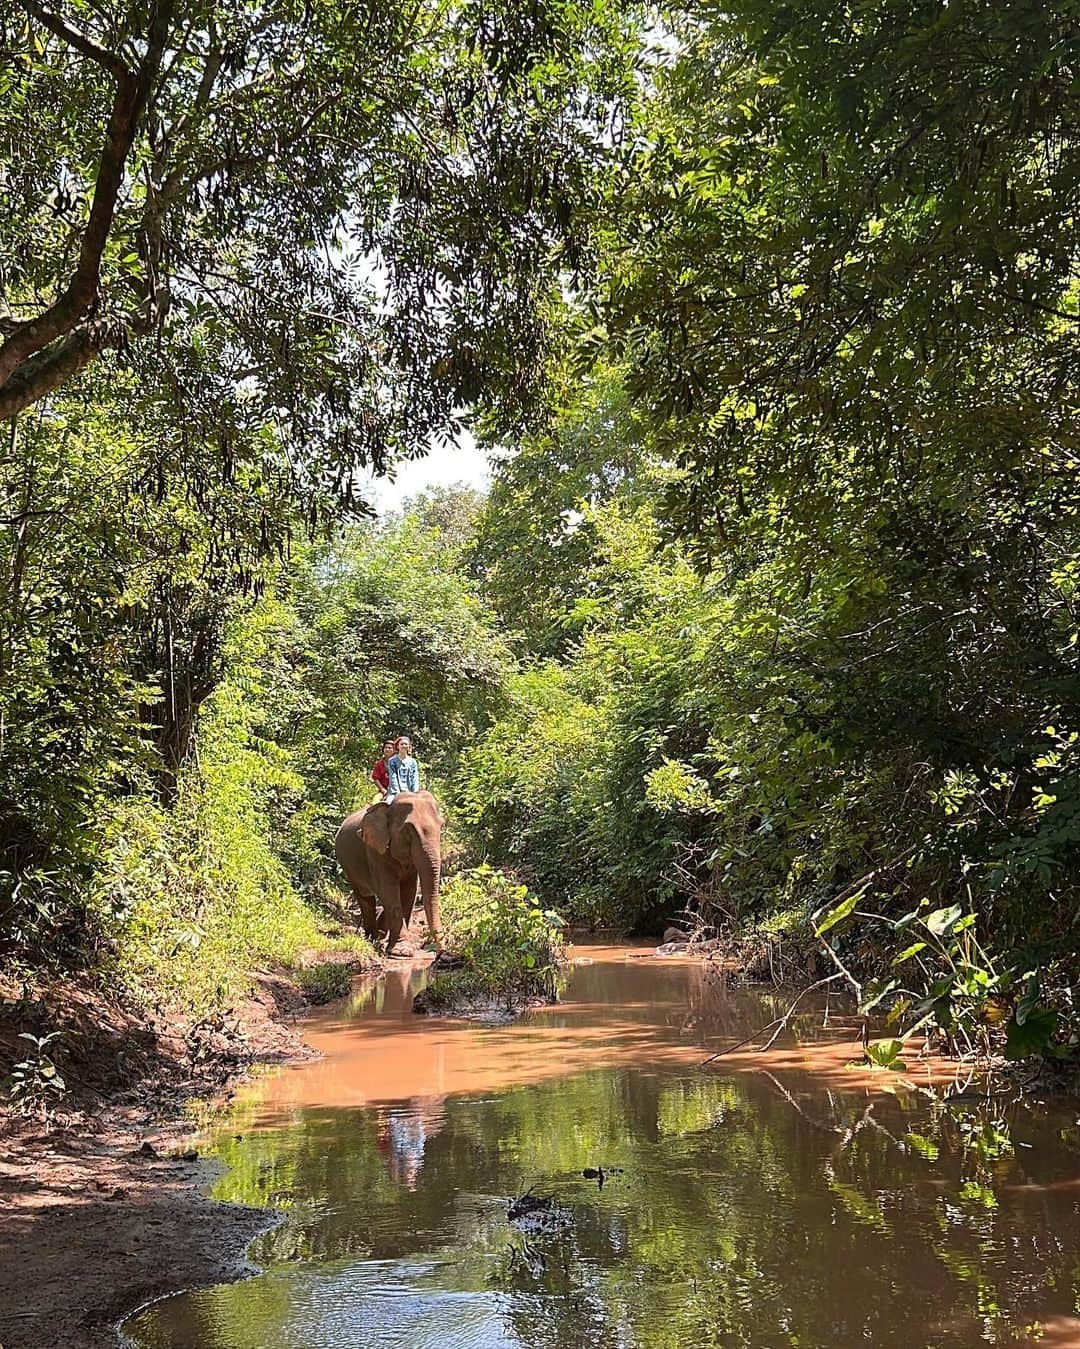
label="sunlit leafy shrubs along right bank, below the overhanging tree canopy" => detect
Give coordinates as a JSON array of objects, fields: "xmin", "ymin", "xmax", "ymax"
[{"xmin": 454, "ymin": 474, "xmax": 1080, "ymax": 1056}]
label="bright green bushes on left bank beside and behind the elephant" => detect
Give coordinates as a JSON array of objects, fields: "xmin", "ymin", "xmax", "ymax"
[{"xmin": 3, "ymin": 482, "xmax": 508, "ymax": 1004}]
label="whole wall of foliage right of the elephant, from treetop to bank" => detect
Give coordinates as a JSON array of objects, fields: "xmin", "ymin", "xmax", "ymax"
[{"xmin": 464, "ymin": 0, "xmax": 1080, "ymax": 1054}]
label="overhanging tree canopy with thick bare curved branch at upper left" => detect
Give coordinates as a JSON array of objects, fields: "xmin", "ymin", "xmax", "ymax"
[{"xmin": 0, "ymin": 0, "xmax": 628, "ymax": 503}]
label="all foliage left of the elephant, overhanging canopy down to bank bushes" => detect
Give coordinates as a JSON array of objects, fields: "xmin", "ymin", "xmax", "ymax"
[{"xmin": 0, "ymin": 0, "xmax": 631, "ymax": 1014}]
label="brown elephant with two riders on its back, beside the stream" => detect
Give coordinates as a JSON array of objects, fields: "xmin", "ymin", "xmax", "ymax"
[{"xmin": 334, "ymin": 792, "xmax": 444, "ymax": 955}]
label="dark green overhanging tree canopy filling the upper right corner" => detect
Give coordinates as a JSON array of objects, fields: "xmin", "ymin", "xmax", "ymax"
[{"xmin": 599, "ymin": 0, "xmax": 1080, "ymax": 552}]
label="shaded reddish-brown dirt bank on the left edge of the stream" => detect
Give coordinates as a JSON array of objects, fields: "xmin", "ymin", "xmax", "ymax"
[{"xmin": 0, "ymin": 973, "xmax": 372, "ymax": 1349}]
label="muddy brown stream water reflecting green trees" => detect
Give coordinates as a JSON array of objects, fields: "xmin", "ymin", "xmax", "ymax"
[{"xmin": 124, "ymin": 947, "xmax": 1080, "ymax": 1349}]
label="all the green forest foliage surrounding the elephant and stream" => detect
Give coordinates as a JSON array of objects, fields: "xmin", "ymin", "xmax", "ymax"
[{"xmin": 0, "ymin": 0, "xmax": 1080, "ymax": 1056}]
